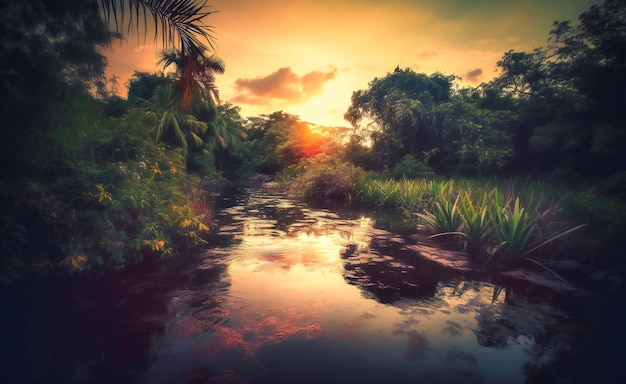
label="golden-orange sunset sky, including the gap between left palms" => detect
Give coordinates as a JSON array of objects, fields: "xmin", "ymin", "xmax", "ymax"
[{"xmin": 105, "ymin": 0, "xmax": 602, "ymax": 126}]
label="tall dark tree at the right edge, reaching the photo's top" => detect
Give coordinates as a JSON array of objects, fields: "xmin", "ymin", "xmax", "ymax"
[{"xmin": 491, "ymin": 0, "xmax": 626, "ymax": 176}]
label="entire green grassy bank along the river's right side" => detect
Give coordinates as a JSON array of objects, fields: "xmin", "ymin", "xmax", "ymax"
[{"xmin": 281, "ymin": 160, "xmax": 626, "ymax": 268}]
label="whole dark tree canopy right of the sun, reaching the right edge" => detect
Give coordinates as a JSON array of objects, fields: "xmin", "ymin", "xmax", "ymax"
[{"xmin": 344, "ymin": 0, "xmax": 626, "ymax": 179}]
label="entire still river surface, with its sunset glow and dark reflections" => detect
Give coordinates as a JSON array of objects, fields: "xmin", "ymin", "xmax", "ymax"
[{"xmin": 0, "ymin": 184, "xmax": 626, "ymax": 384}]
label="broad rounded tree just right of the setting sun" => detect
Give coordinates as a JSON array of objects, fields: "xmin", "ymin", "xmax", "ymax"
[{"xmin": 345, "ymin": 68, "xmax": 511, "ymax": 174}]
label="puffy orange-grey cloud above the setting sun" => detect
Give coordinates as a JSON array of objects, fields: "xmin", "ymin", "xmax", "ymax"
[{"xmin": 233, "ymin": 66, "xmax": 337, "ymax": 104}]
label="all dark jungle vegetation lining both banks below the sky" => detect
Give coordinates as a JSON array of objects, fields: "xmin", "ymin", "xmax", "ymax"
[{"xmin": 0, "ymin": 0, "xmax": 626, "ymax": 282}]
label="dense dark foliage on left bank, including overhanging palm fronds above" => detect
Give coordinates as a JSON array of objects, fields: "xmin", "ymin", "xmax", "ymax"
[{"xmin": 0, "ymin": 0, "xmax": 222, "ymax": 281}]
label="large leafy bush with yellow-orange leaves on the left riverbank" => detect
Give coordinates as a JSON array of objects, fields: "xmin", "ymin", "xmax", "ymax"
[{"xmin": 0, "ymin": 111, "xmax": 210, "ymax": 281}]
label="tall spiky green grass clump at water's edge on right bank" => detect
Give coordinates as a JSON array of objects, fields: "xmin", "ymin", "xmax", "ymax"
[{"xmin": 363, "ymin": 179, "xmax": 583, "ymax": 263}]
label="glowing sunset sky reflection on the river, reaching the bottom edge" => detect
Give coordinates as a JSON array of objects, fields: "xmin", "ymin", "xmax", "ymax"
[{"xmin": 133, "ymin": 190, "xmax": 567, "ymax": 383}]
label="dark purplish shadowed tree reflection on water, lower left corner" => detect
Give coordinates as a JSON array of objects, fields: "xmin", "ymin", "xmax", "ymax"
[{"xmin": 0, "ymin": 258, "xmax": 228, "ymax": 383}]
